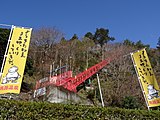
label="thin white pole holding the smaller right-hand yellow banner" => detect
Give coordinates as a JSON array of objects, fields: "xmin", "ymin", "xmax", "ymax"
[{"xmin": 130, "ymin": 51, "xmax": 150, "ymax": 110}]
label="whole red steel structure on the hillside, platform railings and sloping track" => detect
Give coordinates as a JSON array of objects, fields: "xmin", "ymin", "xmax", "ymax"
[{"xmin": 35, "ymin": 59, "xmax": 111, "ymax": 92}]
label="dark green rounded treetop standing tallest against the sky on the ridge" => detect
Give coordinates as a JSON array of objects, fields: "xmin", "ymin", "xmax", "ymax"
[{"xmin": 93, "ymin": 28, "xmax": 115, "ymax": 47}]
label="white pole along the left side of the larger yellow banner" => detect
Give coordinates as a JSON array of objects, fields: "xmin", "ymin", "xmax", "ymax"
[{"xmin": 0, "ymin": 25, "xmax": 14, "ymax": 77}]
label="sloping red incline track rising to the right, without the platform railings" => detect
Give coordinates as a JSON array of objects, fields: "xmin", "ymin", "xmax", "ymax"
[{"xmin": 55, "ymin": 59, "xmax": 110, "ymax": 92}]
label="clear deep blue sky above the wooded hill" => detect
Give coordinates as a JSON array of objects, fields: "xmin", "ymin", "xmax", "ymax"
[{"xmin": 0, "ymin": 0, "xmax": 160, "ymax": 48}]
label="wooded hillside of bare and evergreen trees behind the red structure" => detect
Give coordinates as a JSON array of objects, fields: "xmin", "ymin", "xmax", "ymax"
[{"xmin": 0, "ymin": 28, "xmax": 160, "ymax": 109}]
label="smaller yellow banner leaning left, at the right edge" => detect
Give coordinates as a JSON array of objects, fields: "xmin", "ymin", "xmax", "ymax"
[{"xmin": 131, "ymin": 49, "xmax": 160, "ymax": 107}]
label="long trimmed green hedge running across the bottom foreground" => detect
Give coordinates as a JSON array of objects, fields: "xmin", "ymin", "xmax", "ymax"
[{"xmin": 0, "ymin": 100, "xmax": 160, "ymax": 120}]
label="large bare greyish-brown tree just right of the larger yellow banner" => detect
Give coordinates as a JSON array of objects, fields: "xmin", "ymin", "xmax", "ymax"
[{"xmin": 29, "ymin": 27, "xmax": 65, "ymax": 76}]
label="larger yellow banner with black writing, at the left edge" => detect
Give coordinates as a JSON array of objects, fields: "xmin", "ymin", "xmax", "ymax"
[{"xmin": 0, "ymin": 26, "xmax": 32, "ymax": 94}]
